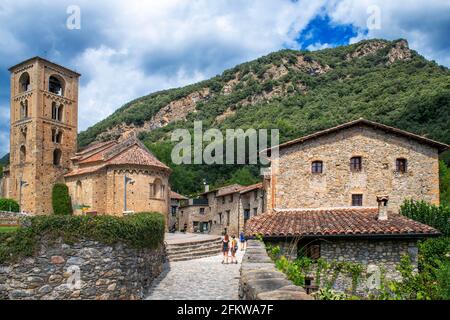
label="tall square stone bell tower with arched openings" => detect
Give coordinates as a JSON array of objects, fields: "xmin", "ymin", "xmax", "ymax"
[{"xmin": 9, "ymin": 57, "xmax": 80, "ymax": 214}]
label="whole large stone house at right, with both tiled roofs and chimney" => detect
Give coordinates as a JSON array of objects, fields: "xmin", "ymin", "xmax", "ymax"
[{"xmin": 246, "ymin": 119, "xmax": 449, "ymax": 292}]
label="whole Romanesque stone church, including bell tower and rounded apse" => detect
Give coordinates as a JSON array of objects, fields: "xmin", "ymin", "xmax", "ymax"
[{"xmin": 2, "ymin": 57, "xmax": 171, "ymax": 220}]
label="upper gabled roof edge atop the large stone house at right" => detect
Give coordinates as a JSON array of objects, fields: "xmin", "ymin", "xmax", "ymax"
[{"xmin": 261, "ymin": 118, "xmax": 450, "ymax": 155}]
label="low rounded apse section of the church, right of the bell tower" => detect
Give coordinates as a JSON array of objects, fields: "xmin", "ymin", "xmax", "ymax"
[{"xmin": 64, "ymin": 137, "xmax": 171, "ymax": 215}]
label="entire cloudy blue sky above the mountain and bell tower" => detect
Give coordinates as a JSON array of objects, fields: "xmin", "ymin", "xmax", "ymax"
[{"xmin": 0, "ymin": 0, "xmax": 450, "ymax": 156}]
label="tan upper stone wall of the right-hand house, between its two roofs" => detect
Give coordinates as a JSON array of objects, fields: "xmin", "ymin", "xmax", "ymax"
[{"xmin": 272, "ymin": 126, "xmax": 439, "ymax": 212}]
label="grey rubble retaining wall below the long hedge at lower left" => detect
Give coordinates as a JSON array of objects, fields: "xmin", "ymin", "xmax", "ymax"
[{"xmin": 0, "ymin": 240, "xmax": 165, "ymax": 300}]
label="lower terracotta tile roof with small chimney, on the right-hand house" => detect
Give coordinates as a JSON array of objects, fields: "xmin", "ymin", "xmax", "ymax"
[{"xmin": 245, "ymin": 208, "xmax": 439, "ymax": 237}]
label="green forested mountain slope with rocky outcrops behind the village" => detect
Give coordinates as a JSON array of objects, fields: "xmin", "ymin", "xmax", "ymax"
[{"xmin": 79, "ymin": 40, "xmax": 450, "ymax": 193}]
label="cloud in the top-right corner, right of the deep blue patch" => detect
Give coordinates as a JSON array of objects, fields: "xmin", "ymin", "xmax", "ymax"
[{"xmin": 326, "ymin": 0, "xmax": 450, "ymax": 66}]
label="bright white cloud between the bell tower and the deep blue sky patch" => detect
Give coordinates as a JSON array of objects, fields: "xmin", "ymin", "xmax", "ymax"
[{"xmin": 73, "ymin": 0, "xmax": 323, "ymax": 130}]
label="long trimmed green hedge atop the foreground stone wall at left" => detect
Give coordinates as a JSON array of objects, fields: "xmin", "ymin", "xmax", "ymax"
[{"xmin": 0, "ymin": 212, "xmax": 165, "ymax": 264}]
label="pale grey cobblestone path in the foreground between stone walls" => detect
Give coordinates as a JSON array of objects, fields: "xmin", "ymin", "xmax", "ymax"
[{"xmin": 147, "ymin": 251, "xmax": 243, "ymax": 300}]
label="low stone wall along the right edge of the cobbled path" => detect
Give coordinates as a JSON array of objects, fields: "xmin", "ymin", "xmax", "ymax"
[{"xmin": 239, "ymin": 240, "xmax": 312, "ymax": 300}]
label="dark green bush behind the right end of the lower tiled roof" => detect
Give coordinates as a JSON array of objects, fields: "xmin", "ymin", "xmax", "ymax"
[{"xmin": 400, "ymin": 200, "xmax": 450, "ymax": 236}]
